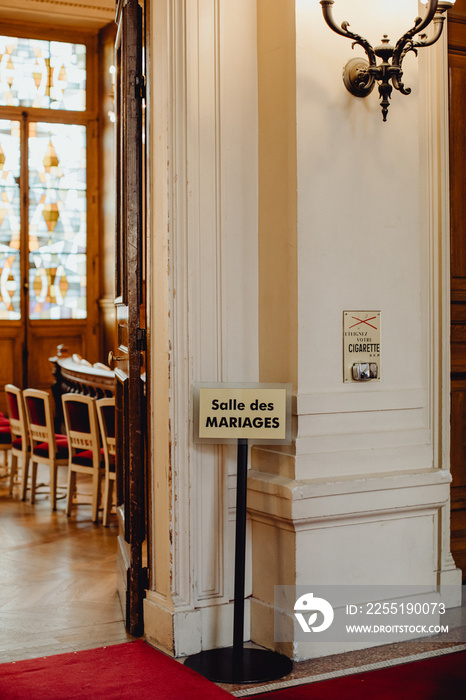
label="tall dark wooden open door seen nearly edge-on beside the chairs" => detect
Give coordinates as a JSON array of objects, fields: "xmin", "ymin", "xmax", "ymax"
[{"xmin": 114, "ymin": 0, "xmax": 145, "ymax": 636}]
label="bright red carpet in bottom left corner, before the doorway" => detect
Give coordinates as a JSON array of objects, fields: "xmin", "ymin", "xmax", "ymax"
[{"xmin": 0, "ymin": 640, "xmax": 232, "ymax": 700}]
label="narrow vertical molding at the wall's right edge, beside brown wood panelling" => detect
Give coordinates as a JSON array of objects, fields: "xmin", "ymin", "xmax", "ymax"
[{"xmin": 419, "ymin": 4, "xmax": 450, "ymax": 468}]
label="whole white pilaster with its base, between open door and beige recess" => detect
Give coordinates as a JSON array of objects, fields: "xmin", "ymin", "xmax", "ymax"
[{"xmin": 145, "ymin": 0, "xmax": 257, "ymax": 653}]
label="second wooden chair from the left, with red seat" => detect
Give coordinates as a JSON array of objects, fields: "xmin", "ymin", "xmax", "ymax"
[{"xmin": 23, "ymin": 389, "xmax": 68, "ymax": 510}]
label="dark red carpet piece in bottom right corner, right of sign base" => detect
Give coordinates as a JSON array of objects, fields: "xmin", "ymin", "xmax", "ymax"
[{"xmin": 252, "ymin": 651, "xmax": 466, "ymax": 700}]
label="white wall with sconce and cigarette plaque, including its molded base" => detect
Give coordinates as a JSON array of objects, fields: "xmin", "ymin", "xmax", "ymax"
[{"xmin": 249, "ymin": 0, "xmax": 461, "ymax": 659}]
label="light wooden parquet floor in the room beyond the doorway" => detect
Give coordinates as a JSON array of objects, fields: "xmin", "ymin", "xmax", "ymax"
[{"xmin": 0, "ymin": 470, "xmax": 132, "ymax": 663}]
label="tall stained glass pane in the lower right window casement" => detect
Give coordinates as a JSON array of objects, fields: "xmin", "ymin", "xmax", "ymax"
[{"xmin": 29, "ymin": 123, "xmax": 87, "ymax": 320}]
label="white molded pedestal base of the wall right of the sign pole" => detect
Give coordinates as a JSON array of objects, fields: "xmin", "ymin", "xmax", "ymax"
[{"xmin": 248, "ymin": 469, "xmax": 461, "ymax": 660}]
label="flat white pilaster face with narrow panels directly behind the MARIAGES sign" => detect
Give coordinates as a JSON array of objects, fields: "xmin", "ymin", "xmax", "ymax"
[{"xmin": 185, "ymin": 0, "xmax": 258, "ymax": 607}]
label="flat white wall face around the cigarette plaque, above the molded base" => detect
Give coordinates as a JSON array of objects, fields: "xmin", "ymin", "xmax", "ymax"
[{"xmin": 297, "ymin": 2, "xmax": 424, "ymax": 477}]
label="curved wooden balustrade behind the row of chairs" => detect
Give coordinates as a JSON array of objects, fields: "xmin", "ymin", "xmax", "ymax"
[{"xmin": 49, "ymin": 345, "xmax": 115, "ymax": 432}]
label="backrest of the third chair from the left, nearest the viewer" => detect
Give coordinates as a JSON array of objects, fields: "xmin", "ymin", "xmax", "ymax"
[{"xmin": 62, "ymin": 394, "xmax": 101, "ymax": 466}]
